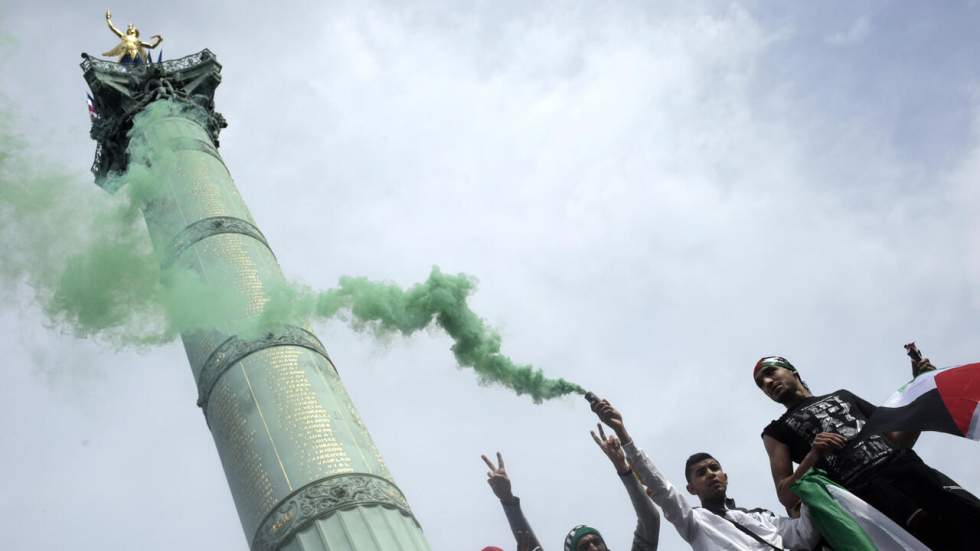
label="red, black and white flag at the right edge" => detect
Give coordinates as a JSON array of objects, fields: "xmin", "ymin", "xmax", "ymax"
[{"xmin": 864, "ymin": 363, "xmax": 980, "ymax": 440}]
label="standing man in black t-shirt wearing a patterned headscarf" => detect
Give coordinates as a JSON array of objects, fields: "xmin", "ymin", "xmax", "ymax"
[{"xmin": 752, "ymin": 356, "xmax": 980, "ymax": 550}]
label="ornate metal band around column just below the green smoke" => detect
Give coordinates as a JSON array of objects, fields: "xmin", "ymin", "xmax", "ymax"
[{"xmin": 197, "ymin": 325, "xmax": 333, "ymax": 417}]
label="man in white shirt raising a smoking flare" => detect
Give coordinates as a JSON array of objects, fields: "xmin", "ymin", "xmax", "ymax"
[{"xmin": 590, "ymin": 398, "xmax": 820, "ymax": 551}]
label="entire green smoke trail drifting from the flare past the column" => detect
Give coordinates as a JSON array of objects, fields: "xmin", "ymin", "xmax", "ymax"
[{"xmin": 0, "ymin": 102, "xmax": 583, "ymax": 402}]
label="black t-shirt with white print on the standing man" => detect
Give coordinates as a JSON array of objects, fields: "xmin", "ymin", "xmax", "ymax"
[{"xmin": 762, "ymin": 390, "xmax": 899, "ymax": 486}]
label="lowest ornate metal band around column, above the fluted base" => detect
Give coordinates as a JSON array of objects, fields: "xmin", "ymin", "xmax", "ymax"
[{"xmin": 252, "ymin": 473, "xmax": 418, "ymax": 551}]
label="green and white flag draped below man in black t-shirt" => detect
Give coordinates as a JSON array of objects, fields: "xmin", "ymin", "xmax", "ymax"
[{"xmin": 790, "ymin": 469, "xmax": 929, "ymax": 551}]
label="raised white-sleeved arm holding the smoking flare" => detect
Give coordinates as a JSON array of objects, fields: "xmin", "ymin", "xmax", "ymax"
[{"xmin": 592, "ymin": 400, "xmax": 698, "ymax": 541}]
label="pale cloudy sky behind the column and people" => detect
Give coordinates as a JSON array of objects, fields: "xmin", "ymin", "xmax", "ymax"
[{"xmin": 0, "ymin": 0, "xmax": 980, "ymax": 551}]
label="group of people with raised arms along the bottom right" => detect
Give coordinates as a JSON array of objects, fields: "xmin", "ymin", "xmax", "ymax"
[{"xmin": 483, "ymin": 356, "xmax": 980, "ymax": 551}]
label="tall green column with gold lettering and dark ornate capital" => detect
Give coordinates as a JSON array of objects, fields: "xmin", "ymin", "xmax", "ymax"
[{"xmin": 82, "ymin": 50, "xmax": 428, "ymax": 551}]
